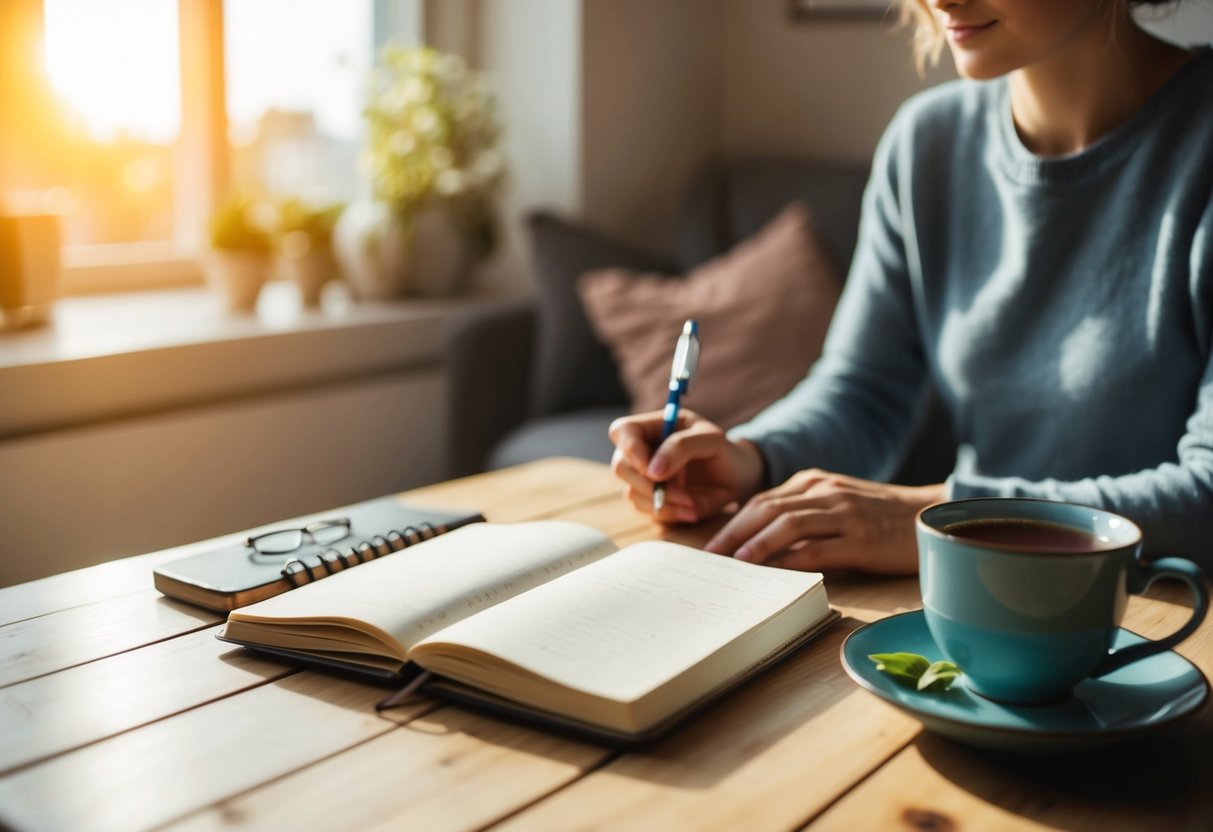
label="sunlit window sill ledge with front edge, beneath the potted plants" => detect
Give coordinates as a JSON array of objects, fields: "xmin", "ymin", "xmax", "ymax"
[{"xmin": 0, "ymin": 283, "xmax": 502, "ymax": 439}]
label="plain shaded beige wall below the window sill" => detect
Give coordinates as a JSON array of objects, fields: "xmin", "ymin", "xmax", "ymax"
[{"xmin": 0, "ymin": 369, "xmax": 445, "ymax": 587}]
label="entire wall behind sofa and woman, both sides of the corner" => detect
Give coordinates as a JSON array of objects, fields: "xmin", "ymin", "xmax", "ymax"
[{"xmin": 465, "ymin": 0, "xmax": 1213, "ymax": 292}]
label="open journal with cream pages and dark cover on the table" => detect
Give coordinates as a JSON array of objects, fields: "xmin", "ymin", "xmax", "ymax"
[{"xmin": 220, "ymin": 520, "xmax": 837, "ymax": 741}]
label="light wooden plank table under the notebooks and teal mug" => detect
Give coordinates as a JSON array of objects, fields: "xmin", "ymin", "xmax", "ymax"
[{"xmin": 0, "ymin": 460, "xmax": 1213, "ymax": 832}]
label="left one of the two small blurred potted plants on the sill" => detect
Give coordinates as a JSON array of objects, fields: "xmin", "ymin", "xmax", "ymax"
[{"xmin": 205, "ymin": 195, "xmax": 274, "ymax": 312}]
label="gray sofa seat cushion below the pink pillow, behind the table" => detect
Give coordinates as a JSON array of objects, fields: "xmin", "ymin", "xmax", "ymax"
[{"xmin": 489, "ymin": 405, "xmax": 627, "ymax": 468}]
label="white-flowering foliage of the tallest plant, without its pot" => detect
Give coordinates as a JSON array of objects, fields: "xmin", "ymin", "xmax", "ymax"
[{"xmin": 364, "ymin": 45, "xmax": 506, "ymax": 255}]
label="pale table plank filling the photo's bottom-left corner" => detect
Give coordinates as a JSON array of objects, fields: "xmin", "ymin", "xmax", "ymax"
[{"xmin": 0, "ymin": 673, "xmax": 432, "ymax": 832}]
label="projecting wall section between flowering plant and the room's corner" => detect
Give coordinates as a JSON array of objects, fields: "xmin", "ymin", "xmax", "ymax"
[{"xmin": 473, "ymin": 0, "xmax": 724, "ymax": 280}]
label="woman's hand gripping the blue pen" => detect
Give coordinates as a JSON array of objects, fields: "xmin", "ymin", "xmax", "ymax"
[{"xmin": 608, "ymin": 408, "xmax": 763, "ymax": 523}]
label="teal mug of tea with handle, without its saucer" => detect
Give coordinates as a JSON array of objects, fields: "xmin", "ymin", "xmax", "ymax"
[{"xmin": 917, "ymin": 497, "xmax": 1208, "ymax": 705}]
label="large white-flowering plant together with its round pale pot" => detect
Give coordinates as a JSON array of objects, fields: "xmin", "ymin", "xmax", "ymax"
[{"xmin": 336, "ymin": 45, "xmax": 505, "ymax": 297}]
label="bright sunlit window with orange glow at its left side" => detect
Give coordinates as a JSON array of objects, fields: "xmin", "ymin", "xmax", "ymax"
[{"xmin": 0, "ymin": 0, "xmax": 420, "ymax": 291}]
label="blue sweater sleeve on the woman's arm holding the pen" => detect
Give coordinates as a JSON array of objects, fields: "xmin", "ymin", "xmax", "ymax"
[{"xmin": 729, "ymin": 110, "xmax": 926, "ymax": 485}]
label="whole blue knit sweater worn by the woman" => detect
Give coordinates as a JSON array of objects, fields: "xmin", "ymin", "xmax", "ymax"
[{"xmin": 730, "ymin": 51, "xmax": 1213, "ymax": 566}]
